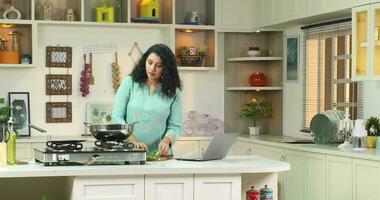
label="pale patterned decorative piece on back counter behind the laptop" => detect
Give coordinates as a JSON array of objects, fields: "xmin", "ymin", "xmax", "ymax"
[{"xmin": 183, "ymin": 111, "xmax": 224, "ymax": 135}]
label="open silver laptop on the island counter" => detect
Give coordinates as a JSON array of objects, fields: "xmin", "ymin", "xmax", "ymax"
[{"xmin": 175, "ymin": 133, "xmax": 237, "ymax": 161}]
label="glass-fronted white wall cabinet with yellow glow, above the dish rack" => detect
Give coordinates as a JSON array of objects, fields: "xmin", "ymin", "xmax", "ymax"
[{"xmin": 352, "ymin": 3, "xmax": 380, "ymax": 81}]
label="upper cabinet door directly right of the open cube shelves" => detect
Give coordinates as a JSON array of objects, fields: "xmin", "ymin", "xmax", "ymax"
[{"xmin": 217, "ymin": 0, "xmax": 254, "ymax": 30}]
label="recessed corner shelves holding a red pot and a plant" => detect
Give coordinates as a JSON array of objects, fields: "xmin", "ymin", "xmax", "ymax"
[{"xmin": 224, "ymin": 32, "xmax": 283, "ymax": 135}]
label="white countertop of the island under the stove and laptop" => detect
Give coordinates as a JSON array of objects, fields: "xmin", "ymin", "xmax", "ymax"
[{"xmin": 0, "ymin": 156, "xmax": 290, "ymax": 178}]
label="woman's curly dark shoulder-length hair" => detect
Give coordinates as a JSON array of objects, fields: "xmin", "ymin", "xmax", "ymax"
[{"xmin": 131, "ymin": 44, "xmax": 182, "ymax": 98}]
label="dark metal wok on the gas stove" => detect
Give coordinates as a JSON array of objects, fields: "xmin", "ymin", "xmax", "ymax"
[{"xmin": 84, "ymin": 122, "xmax": 137, "ymax": 141}]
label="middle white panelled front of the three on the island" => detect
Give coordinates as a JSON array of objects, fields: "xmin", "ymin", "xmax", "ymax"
[{"xmin": 145, "ymin": 174, "xmax": 193, "ymax": 200}]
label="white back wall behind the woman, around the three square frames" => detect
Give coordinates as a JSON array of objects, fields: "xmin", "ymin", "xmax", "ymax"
[{"xmin": 0, "ymin": 25, "xmax": 224, "ymax": 136}]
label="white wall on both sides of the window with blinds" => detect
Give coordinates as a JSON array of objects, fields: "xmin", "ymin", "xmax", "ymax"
[{"xmin": 283, "ymin": 26, "xmax": 380, "ymax": 138}]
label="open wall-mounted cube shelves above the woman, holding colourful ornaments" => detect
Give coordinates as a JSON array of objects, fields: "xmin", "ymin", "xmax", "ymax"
[{"xmin": 0, "ymin": 0, "xmax": 217, "ymax": 71}]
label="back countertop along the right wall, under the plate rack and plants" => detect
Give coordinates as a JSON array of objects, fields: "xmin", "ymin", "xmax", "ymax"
[{"xmin": 238, "ymin": 135, "xmax": 380, "ymax": 161}]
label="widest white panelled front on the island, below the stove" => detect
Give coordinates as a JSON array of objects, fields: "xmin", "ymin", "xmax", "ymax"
[{"xmin": 71, "ymin": 175, "xmax": 144, "ymax": 200}]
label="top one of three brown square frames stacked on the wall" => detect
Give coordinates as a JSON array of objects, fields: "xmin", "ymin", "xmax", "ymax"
[{"xmin": 46, "ymin": 46, "xmax": 72, "ymax": 68}]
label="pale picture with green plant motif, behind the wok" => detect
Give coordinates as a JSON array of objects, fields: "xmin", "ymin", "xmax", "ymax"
[{"xmin": 86, "ymin": 102, "xmax": 112, "ymax": 125}]
